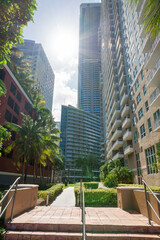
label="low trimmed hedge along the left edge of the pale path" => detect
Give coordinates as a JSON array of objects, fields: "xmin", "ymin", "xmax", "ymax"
[{"xmin": 38, "ymin": 184, "xmax": 64, "ymax": 203}]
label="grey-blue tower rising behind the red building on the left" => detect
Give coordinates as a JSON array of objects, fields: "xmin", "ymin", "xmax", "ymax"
[{"xmin": 18, "ymin": 40, "xmax": 55, "ymax": 112}]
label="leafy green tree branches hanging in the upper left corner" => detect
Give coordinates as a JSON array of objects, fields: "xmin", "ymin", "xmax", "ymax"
[{"xmin": 0, "ymin": 0, "xmax": 36, "ymax": 67}]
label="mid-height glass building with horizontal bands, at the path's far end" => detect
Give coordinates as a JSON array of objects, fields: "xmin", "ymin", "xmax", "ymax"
[{"xmin": 60, "ymin": 106, "xmax": 101, "ymax": 181}]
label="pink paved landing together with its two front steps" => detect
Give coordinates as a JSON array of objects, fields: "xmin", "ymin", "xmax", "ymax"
[{"xmin": 4, "ymin": 206, "xmax": 160, "ymax": 240}]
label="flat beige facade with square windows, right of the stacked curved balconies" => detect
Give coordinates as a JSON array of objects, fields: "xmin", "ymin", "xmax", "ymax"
[{"xmin": 123, "ymin": 0, "xmax": 160, "ymax": 185}]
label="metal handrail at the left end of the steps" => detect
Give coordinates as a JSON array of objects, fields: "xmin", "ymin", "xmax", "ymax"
[{"xmin": 0, "ymin": 177, "xmax": 21, "ymax": 221}]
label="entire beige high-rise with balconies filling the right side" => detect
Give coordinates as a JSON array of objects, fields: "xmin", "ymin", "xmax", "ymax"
[{"xmin": 101, "ymin": 0, "xmax": 160, "ymax": 185}]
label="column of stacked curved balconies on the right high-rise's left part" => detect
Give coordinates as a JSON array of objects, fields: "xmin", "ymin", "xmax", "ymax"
[{"xmin": 101, "ymin": 0, "xmax": 132, "ymax": 163}]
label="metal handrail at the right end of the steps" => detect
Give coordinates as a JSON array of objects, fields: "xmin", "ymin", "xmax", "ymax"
[{"xmin": 142, "ymin": 180, "xmax": 160, "ymax": 225}]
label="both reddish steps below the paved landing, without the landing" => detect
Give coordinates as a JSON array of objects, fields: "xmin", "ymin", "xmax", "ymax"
[{"xmin": 4, "ymin": 220, "xmax": 160, "ymax": 240}]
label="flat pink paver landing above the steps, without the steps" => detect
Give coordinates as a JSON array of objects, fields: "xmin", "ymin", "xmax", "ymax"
[{"xmin": 12, "ymin": 206, "xmax": 158, "ymax": 227}]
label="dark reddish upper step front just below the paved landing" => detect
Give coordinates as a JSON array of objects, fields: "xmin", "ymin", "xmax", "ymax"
[{"xmin": 7, "ymin": 223, "xmax": 160, "ymax": 234}]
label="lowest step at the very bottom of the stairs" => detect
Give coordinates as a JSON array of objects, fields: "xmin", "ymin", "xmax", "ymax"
[{"xmin": 4, "ymin": 231, "xmax": 160, "ymax": 240}]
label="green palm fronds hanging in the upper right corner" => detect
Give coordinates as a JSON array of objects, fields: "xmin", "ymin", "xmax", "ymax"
[{"xmin": 127, "ymin": 0, "xmax": 160, "ymax": 38}]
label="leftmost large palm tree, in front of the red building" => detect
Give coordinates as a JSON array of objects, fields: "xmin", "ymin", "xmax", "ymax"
[{"xmin": 5, "ymin": 114, "xmax": 44, "ymax": 182}]
